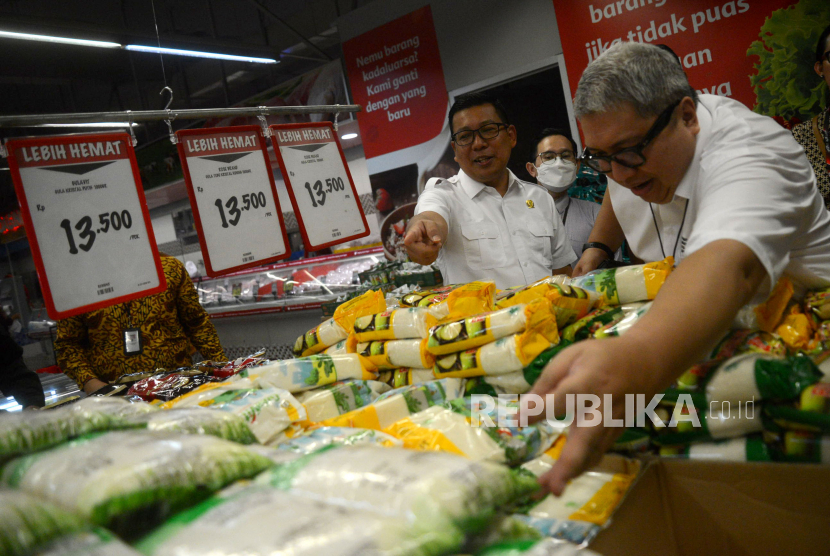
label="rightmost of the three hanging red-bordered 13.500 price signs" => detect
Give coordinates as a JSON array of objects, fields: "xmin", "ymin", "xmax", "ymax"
[{"xmin": 271, "ymin": 122, "xmax": 369, "ymax": 251}]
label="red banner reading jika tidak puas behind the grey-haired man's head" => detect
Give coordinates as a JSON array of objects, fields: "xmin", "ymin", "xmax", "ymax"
[{"xmin": 553, "ymin": 0, "xmax": 799, "ymax": 107}]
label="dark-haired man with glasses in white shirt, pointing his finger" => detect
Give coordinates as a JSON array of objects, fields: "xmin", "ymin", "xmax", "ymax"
[{"xmin": 404, "ymin": 94, "xmax": 576, "ymax": 289}]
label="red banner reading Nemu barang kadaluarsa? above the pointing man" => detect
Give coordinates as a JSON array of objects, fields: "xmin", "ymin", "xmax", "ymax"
[{"xmin": 343, "ymin": 6, "xmax": 448, "ymax": 158}]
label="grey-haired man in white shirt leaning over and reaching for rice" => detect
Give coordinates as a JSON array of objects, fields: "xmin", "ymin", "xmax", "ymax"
[{"xmin": 532, "ymin": 43, "xmax": 830, "ymax": 494}]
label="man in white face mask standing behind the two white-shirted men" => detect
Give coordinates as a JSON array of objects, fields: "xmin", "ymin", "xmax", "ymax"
[{"xmin": 527, "ymin": 128, "xmax": 600, "ymax": 263}]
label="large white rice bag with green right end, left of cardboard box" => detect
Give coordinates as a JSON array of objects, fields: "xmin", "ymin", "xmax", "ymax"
[{"xmin": 256, "ymin": 446, "xmax": 539, "ymax": 533}]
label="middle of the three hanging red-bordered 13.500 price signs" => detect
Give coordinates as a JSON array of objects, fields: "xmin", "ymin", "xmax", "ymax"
[{"xmin": 176, "ymin": 125, "xmax": 291, "ymax": 276}]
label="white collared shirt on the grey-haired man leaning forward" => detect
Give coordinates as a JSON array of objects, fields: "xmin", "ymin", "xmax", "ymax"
[{"xmin": 608, "ymin": 95, "xmax": 830, "ymax": 301}]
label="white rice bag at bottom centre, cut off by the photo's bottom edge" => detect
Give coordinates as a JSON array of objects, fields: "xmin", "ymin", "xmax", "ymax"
[{"xmin": 137, "ymin": 482, "xmax": 463, "ymax": 556}]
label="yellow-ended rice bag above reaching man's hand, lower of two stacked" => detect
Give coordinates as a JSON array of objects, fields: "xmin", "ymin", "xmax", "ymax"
[{"xmin": 433, "ymin": 313, "xmax": 559, "ymax": 378}]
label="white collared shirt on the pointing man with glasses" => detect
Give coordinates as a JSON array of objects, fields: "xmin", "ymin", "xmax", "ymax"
[{"xmin": 415, "ymin": 170, "xmax": 575, "ymax": 289}]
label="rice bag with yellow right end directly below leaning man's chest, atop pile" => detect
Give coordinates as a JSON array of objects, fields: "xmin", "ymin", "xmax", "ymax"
[{"xmin": 571, "ymin": 257, "xmax": 674, "ymax": 305}]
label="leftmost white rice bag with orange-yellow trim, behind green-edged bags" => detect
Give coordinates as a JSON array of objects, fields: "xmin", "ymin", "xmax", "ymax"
[{"xmin": 161, "ymin": 378, "xmax": 306, "ymax": 444}]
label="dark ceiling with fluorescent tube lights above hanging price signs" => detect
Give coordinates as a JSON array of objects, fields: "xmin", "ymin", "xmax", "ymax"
[{"xmin": 0, "ymin": 0, "xmax": 371, "ymax": 214}]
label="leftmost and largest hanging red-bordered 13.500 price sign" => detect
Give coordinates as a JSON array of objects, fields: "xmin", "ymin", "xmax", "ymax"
[{"xmin": 7, "ymin": 133, "xmax": 166, "ymax": 319}]
